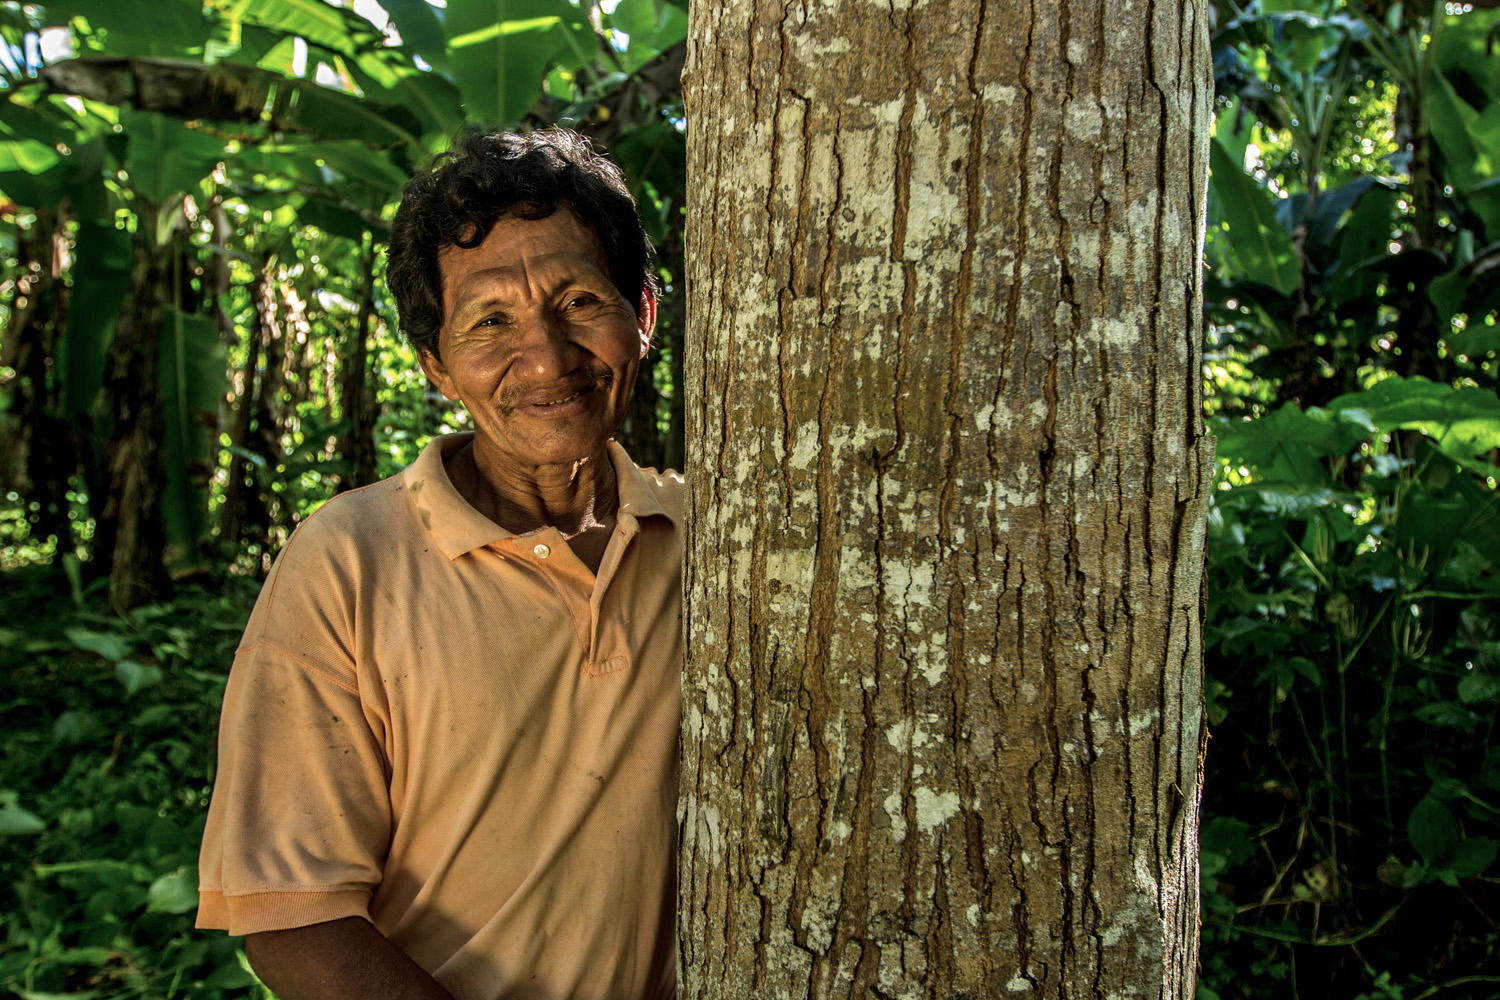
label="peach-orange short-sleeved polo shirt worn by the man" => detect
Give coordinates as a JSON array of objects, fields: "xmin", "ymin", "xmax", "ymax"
[{"xmin": 198, "ymin": 435, "xmax": 683, "ymax": 1000}]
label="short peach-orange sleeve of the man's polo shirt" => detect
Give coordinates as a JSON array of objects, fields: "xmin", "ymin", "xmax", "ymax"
[{"xmin": 198, "ymin": 527, "xmax": 392, "ymax": 934}]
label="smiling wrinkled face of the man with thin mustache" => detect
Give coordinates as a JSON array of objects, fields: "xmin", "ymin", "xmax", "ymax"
[{"xmin": 422, "ymin": 205, "xmax": 656, "ymax": 472}]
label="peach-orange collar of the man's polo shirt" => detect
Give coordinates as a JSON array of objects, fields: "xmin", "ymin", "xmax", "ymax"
[{"xmin": 402, "ymin": 432, "xmax": 675, "ymax": 559}]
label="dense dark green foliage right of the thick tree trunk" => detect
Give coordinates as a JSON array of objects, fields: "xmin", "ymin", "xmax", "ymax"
[{"xmin": 1200, "ymin": 0, "xmax": 1500, "ymax": 1000}]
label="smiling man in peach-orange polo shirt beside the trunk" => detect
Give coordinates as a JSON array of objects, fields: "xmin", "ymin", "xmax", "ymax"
[{"xmin": 198, "ymin": 130, "xmax": 683, "ymax": 1000}]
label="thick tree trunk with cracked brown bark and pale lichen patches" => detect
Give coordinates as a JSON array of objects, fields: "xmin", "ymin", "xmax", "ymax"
[{"xmin": 680, "ymin": 0, "xmax": 1212, "ymax": 1000}]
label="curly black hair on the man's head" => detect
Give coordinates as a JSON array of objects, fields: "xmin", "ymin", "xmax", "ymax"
[{"xmin": 386, "ymin": 126, "xmax": 659, "ymax": 357}]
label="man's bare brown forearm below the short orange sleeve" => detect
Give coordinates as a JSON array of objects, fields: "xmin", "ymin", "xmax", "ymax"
[{"xmin": 245, "ymin": 916, "xmax": 453, "ymax": 1000}]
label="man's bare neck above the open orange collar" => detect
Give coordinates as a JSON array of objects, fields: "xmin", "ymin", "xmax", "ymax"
[{"xmin": 446, "ymin": 442, "xmax": 620, "ymax": 538}]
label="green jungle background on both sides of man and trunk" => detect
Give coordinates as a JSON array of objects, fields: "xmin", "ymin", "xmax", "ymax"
[{"xmin": 0, "ymin": 0, "xmax": 1500, "ymax": 1000}]
